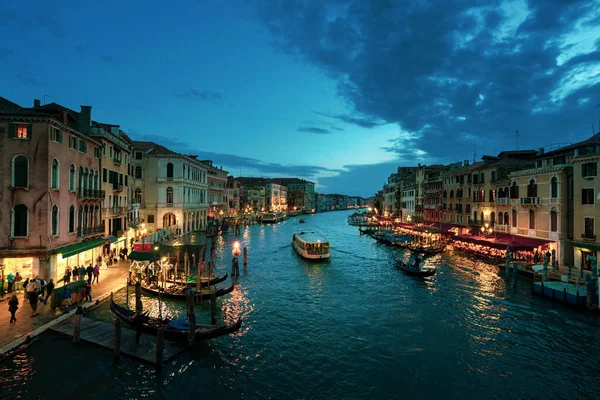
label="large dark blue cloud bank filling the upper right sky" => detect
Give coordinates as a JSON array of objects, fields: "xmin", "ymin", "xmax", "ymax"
[{"xmin": 259, "ymin": 0, "xmax": 600, "ymax": 163}]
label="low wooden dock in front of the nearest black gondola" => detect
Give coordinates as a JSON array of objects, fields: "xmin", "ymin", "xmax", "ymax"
[{"xmin": 50, "ymin": 317, "xmax": 184, "ymax": 364}]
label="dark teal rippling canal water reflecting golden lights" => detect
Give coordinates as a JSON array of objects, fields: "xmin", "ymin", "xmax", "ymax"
[{"xmin": 0, "ymin": 212, "xmax": 600, "ymax": 399}]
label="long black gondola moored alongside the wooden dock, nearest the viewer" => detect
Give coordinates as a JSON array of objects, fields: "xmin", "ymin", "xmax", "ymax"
[{"xmin": 110, "ymin": 294, "xmax": 242, "ymax": 342}]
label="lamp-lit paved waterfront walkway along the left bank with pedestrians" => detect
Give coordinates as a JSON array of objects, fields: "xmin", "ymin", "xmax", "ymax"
[{"xmin": 0, "ymin": 260, "xmax": 129, "ymax": 355}]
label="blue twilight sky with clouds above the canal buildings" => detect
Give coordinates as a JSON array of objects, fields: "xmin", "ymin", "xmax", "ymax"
[{"xmin": 0, "ymin": 0, "xmax": 600, "ymax": 197}]
